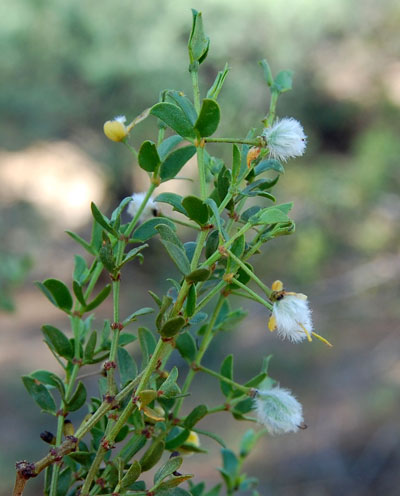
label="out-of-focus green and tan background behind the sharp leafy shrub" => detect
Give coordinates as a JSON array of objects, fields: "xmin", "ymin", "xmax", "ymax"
[{"xmin": 0, "ymin": 0, "xmax": 400, "ymax": 496}]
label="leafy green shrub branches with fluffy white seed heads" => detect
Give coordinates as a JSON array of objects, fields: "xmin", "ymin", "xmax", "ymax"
[{"xmin": 14, "ymin": 10, "xmax": 330, "ymax": 496}]
